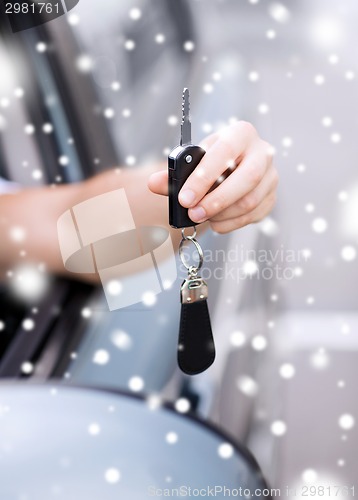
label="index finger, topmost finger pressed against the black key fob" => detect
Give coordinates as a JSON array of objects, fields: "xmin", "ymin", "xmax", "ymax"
[{"xmin": 179, "ymin": 121, "xmax": 257, "ymax": 209}]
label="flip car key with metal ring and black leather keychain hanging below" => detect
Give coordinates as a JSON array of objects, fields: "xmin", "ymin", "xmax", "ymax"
[{"xmin": 168, "ymin": 88, "xmax": 215, "ymax": 375}]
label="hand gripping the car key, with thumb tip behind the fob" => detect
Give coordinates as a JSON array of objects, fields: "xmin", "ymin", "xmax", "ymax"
[{"xmin": 148, "ymin": 121, "xmax": 278, "ymax": 233}]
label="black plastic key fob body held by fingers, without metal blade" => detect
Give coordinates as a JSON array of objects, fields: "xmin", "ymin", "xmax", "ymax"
[{"xmin": 168, "ymin": 144, "xmax": 205, "ymax": 228}]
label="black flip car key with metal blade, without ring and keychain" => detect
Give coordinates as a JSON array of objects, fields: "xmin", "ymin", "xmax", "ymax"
[{"xmin": 168, "ymin": 88, "xmax": 205, "ymax": 228}]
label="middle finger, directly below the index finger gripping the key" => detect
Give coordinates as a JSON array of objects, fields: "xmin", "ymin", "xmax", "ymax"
[{"xmin": 189, "ymin": 143, "xmax": 271, "ymax": 222}]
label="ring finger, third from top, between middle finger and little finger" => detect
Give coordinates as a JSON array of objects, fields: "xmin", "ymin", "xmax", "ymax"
[{"xmin": 210, "ymin": 165, "xmax": 278, "ymax": 222}]
